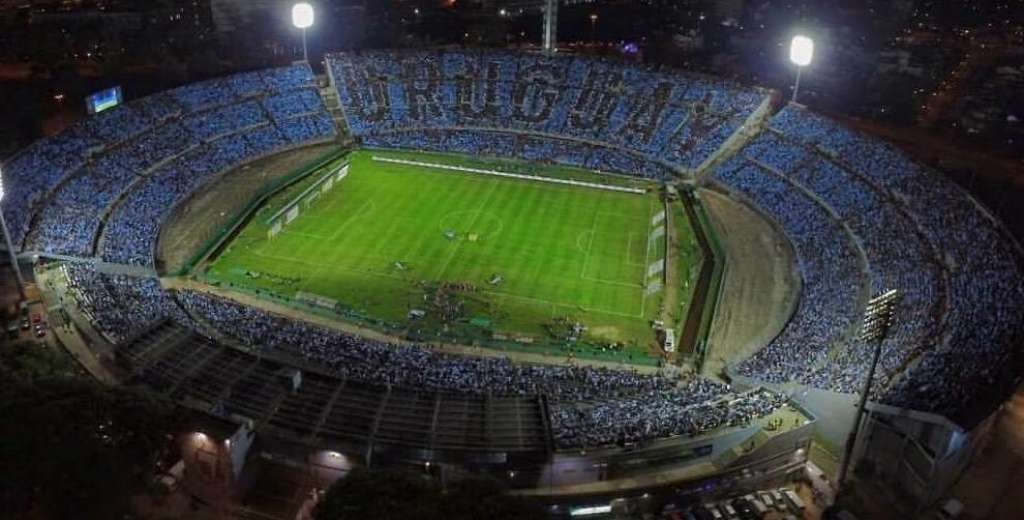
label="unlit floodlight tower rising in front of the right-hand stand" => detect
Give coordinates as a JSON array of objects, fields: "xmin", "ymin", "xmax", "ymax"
[{"xmin": 836, "ymin": 290, "xmax": 900, "ymax": 496}]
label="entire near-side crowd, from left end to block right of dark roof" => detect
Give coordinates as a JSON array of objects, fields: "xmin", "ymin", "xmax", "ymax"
[{"xmin": 54, "ymin": 263, "xmax": 785, "ymax": 448}]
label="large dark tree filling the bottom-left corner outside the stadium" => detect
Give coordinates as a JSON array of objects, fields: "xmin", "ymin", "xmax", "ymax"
[{"xmin": 0, "ymin": 362, "xmax": 178, "ymax": 519}]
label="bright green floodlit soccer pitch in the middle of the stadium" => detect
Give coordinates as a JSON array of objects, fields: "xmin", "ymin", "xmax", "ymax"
[{"xmin": 205, "ymin": 150, "xmax": 697, "ymax": 352}]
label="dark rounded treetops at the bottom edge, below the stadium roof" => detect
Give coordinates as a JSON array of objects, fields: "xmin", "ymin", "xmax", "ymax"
[{"xmin": 315, "ymin": 469, "xmax": 546, "ymax": 520}]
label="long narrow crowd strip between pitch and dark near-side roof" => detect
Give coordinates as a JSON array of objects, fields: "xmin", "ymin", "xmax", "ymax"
[{"xmin": 177, "ymin": 291, "xmax": 673, "ymax": 399}]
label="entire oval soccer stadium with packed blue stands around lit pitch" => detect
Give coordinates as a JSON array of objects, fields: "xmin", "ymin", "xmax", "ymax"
[{"xmin": 3, "ymin": 43, "xmax": 1024, "ymax": 515}]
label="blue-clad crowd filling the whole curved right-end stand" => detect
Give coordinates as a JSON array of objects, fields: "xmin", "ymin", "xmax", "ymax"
[{"xmin": 716, "ymin": 106, "xmax": 1024, "ymax": 422}]
